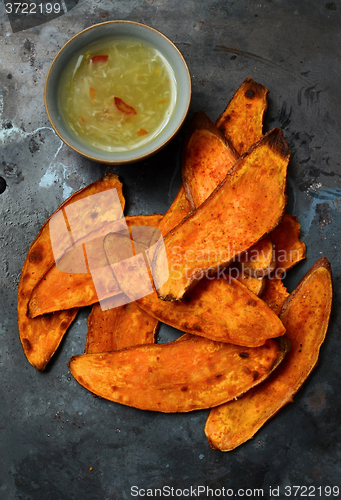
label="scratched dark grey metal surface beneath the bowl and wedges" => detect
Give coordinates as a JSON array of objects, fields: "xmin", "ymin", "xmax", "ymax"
[{"xmin": 0, "ymin": 0, "xmax": 341, "ymax": 500}]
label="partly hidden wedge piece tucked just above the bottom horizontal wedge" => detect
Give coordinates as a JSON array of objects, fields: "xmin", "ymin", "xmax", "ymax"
[{"xmin": 85, "ymin": 302, "xmax": 159, "ymax": 354}]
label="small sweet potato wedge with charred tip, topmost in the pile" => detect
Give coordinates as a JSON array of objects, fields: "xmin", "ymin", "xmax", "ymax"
[{"xmin": 216, "ymin": 78, "xmax": 269, "ymax": 155}]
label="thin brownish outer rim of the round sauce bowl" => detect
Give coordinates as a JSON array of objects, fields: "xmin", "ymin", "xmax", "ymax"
[{"xmin": 44, "ymin": 19, "xmax": 192, "ymax": 165}]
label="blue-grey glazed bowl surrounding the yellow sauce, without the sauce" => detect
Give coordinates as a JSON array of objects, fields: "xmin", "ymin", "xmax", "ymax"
[{"xmin": 44, "ymin": 21, "xmax": 192, "ymax": 165}]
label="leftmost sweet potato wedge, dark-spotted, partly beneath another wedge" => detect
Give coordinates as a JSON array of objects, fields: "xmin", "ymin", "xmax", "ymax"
[{"xmin": 18, "ymin": 174, "xmax": 124, "ymax": 370}]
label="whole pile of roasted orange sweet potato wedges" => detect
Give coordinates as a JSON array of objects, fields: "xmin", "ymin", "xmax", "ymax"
[{"xmin": 18, "ymin": 79, "xmax": 332, "ymax": 451}]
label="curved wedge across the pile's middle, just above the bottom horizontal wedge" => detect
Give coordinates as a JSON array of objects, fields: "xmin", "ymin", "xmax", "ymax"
[{"xmin": 104, "ymin": 241, "xmax": 285, "ymax": 346}]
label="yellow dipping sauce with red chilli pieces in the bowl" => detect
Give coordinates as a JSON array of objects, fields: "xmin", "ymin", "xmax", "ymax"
[{"xmin": 59, "ymin": 37, "xmax": 177, "ymax": 152}]
